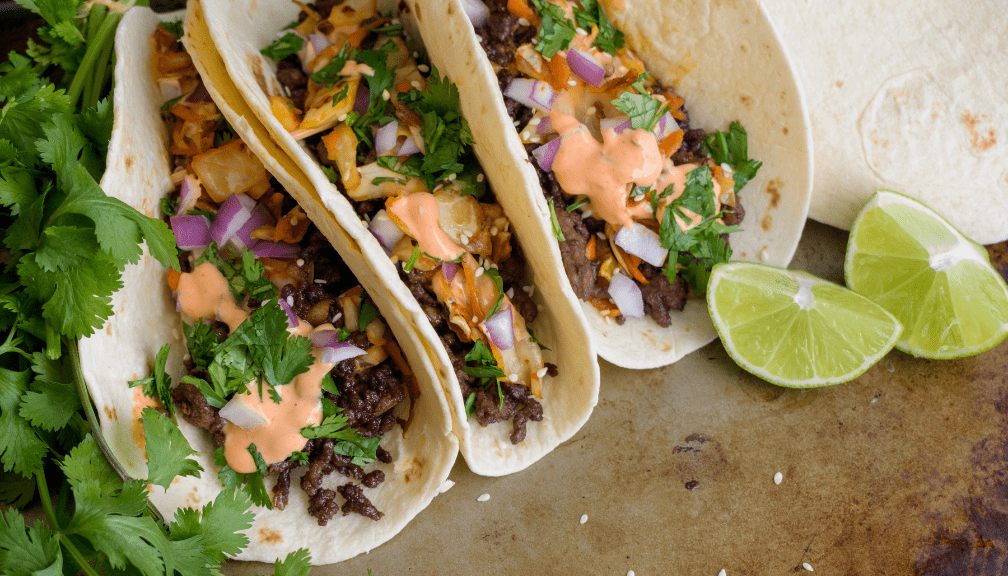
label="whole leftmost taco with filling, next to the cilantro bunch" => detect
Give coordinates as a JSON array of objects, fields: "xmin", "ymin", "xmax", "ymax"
[{"xmin": 80, "ymin": 9, "xmax": 458, "ymax": 564}]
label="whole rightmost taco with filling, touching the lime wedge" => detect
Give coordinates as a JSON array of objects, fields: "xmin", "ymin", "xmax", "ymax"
[{"xmin": 410, "ymin": 0, "xmax": 811, "ymax": 368}]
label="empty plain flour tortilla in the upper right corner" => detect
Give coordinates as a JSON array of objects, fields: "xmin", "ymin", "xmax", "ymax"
[{"xmin": 765, "ymin": 0, "xmax": 1008, "ymax": 244}]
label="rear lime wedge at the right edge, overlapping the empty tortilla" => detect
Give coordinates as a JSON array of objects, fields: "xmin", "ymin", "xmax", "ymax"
[{"xmin": 844, "ymin": 190, "xmax": 1008, "ymax": 358}]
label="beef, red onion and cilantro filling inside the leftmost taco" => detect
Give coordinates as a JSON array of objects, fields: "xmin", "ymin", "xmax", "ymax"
[{"xmin": 144, "ymin": 22, "xmax": 419, "ymax": 526}]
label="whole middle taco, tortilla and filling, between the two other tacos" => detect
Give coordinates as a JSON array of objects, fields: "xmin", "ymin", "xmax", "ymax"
[{"xmin": 186, "ymin": 0, "xmax": 599, "ymax": 475}]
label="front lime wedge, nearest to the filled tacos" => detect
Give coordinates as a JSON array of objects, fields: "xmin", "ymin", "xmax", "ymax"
[{"xmin": 707, "ymin": 262, "xmax": 900, "ymax": 387}]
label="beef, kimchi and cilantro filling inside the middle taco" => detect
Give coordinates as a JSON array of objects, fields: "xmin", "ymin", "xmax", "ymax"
[{"xmin": 262, "ymin": 1, "xmax": 555, "ymax": 444}]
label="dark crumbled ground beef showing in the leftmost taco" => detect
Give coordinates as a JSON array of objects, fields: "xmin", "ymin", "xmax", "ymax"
[{"xmin": 171, "ymin": 231, "xmax": 403, "ymax": 526}]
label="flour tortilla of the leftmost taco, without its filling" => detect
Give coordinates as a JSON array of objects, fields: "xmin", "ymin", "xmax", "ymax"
[{"xmin": 80, "ymin": 8, "xmax": 458, "ymax": 564}]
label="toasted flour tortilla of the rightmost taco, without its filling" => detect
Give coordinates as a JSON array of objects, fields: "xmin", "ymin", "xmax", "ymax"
[{"xmin": 407, "ymin": 0, "xmax": 812, "ymax": 368}]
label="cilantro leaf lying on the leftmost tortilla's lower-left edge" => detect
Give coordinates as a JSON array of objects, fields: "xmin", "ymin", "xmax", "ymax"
[{"xmin": 142, "ymin": 407, "xmax": 203, "ymax": 490}]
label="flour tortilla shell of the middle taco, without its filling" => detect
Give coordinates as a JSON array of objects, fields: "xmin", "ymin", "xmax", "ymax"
[{"xmin": 187, "ymin": 0, "xmax": 599, "ymax": 476}]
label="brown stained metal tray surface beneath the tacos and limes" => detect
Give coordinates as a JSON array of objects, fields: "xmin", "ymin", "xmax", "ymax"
[{"xmin": 227, "ymin": 222, "xmax": 1008, "ymax": 576}]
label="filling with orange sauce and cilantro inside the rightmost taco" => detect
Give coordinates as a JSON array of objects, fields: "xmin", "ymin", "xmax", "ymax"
[{"xmin": 466, "ymin": 0, "xmax": 760, "ymax": 327}]
